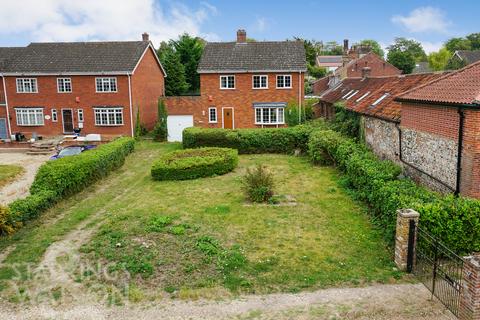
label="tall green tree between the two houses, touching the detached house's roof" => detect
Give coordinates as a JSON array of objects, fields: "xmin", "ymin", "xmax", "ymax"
[{"xmin": 170, "ymin": 33, "xmax": 205, "ymax": 92}]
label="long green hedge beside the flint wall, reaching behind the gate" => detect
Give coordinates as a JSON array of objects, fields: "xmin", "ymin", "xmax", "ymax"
[{"xmin": 308, "ymin": 130, "xmax": 480, "ymax": 254}]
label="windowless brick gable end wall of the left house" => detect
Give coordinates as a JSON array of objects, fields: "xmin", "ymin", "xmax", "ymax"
[{"xmin": 131, "ymin": 48, "xmax": 165, "ymax": 130}]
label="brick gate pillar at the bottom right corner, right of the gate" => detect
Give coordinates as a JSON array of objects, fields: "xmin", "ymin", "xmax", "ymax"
[{"xmin": 458, "ymin": 253, "xmax": 480, "ymax": 320}]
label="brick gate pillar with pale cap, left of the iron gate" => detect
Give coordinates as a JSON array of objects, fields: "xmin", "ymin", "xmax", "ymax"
[{"xmin": 395, "ymin": 209, "xmax": 420, "ymax": 271}]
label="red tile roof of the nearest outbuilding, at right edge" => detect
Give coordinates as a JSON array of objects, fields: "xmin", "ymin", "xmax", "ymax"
[{"xmin": 398, "ymin": 61, "xmax": 480, "ymax": 106}]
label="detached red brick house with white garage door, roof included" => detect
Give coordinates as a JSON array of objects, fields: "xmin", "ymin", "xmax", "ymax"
[{"xmin": 166, "ymin": 30, "xmax": 307, "ymax": 140}]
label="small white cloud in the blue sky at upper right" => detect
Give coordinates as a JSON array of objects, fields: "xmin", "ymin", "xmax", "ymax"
[{"xmin": 392, "ymin": 7, "xmax": 452, "ymax": 33}]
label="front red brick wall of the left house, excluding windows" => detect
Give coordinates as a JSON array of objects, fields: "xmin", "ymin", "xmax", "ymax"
[{"xmin": 5, "ymin": 76, "xmax": 131, "ymax": 137}]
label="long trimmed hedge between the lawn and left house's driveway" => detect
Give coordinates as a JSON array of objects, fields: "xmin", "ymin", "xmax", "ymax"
[{"xmin": 8, "ymin": 138, "xmax": 135, "ymax": 226}]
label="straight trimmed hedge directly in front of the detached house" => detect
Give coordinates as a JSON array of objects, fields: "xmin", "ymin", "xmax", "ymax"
[{"xmin": 183, "ymin": 125, "xmax": 314, "ymax": 154}]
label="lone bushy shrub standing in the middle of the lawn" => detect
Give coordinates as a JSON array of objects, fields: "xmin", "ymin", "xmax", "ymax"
[{"xmin": 243, "ymin": 164, "xmax": 273, "ymax": 202}]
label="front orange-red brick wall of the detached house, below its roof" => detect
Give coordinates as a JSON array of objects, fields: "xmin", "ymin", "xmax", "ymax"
[{"xmin": 200, "ymin": 72, "xmax": 304, "ymax": 128}]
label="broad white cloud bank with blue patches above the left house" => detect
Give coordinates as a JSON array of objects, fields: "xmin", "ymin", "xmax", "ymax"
[{"xmin": 0, "ymin": 0, "xmax": 218, "ymax": 45}]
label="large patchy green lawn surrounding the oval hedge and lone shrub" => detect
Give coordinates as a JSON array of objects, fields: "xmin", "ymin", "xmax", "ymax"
[{"xmin": 0, "ymin": 142, "xmax": 401, "ymax": 298}]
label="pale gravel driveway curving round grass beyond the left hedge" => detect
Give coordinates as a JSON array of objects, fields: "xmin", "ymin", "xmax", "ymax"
[{"xmin": 0, "ymin": 153, "xmax": 50, "ymax": 205}]
